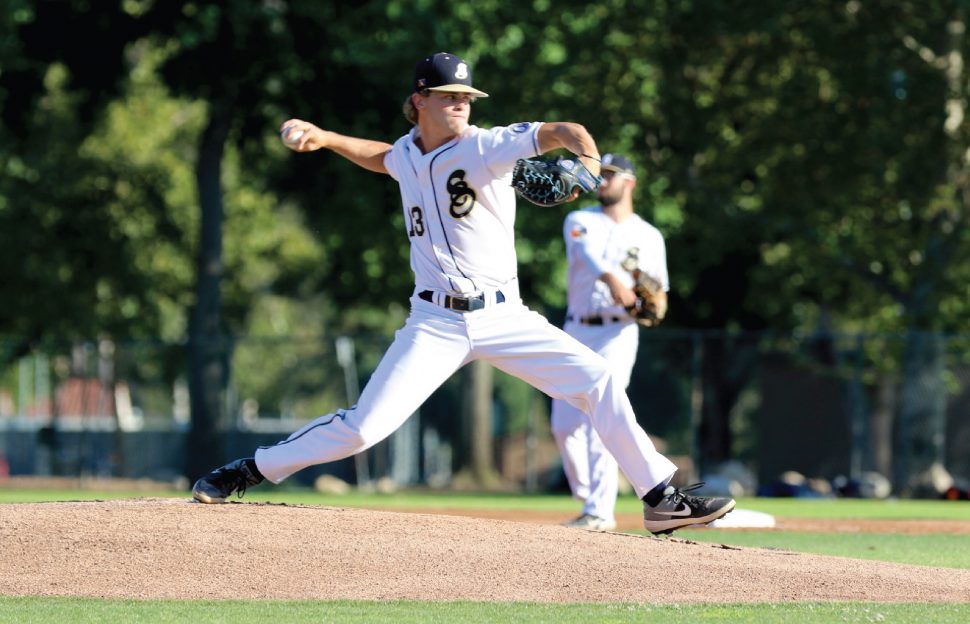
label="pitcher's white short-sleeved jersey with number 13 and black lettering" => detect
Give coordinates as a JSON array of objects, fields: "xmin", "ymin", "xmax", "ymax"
[{"xmin": 384, "ymin": 122, "xmax": 542, "ymax": 293}]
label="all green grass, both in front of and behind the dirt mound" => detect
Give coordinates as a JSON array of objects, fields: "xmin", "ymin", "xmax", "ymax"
[{"xmin": 0, "ymin": 489, "xmax": 970, "ymax": 624}]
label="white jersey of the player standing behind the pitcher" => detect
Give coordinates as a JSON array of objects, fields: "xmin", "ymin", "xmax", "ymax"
[{"xmin": 563, "ymin": 206, "xmax": 670, "ymax": 317}]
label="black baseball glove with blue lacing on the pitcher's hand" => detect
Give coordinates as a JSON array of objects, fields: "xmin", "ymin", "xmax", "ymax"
[{"xmin": 512, "ymin": 158, "xmax": 603, "ymax": 206}]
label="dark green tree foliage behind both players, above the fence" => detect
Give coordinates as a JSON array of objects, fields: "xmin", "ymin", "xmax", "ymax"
[{"xmin": 0, "ymin": 0, "xmax": 970, "ymax": 486}]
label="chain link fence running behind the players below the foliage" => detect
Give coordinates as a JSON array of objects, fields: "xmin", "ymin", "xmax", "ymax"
[{"xmin": 0, "ymin": 329, "xmax": 970, "ymax": 495}]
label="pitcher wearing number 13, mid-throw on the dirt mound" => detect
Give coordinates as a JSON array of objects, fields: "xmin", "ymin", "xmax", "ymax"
[{"xmin": 192, "ymin": 52, "xmax": 734, "ymax": 533}]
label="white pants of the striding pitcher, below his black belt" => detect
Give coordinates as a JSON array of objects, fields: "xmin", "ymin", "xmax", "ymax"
[{"xmin": 256, "ymin": 292, "xmax": 676, "ymax": 497}]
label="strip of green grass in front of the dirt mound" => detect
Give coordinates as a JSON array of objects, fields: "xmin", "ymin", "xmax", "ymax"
[{"xmin": 0, "ymin": 598, "xmax": 970, "ymax": 624}]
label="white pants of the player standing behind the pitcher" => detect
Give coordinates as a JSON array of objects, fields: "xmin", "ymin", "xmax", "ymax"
[{"xmin": 551, "ymin": 321, "xmax": 640, "ymax": 520}]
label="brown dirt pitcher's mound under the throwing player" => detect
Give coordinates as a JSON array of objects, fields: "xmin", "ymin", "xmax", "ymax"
[{"xmin": 0, "ymin": 498, "xmax": 970, "ymax": 603}]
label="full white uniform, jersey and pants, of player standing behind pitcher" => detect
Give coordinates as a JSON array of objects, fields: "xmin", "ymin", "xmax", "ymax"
[{"xmin": 551, "ymin": 206, "xmax": 669, "ymax": 521}]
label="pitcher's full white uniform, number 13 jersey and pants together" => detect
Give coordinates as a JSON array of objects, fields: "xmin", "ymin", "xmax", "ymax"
[{"xmin": 255, "ymin": 122, "xmax": 675, "ymax": 496}]
